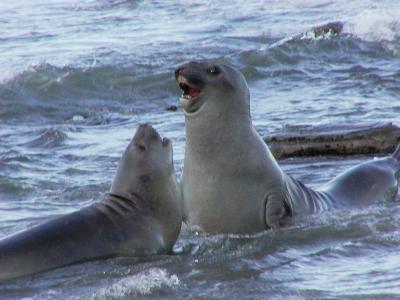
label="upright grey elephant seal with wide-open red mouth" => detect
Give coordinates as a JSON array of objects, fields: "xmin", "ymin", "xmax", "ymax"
[{"xmin": 175, "ymin": 62, "xmax": 400, "ymax": 233}]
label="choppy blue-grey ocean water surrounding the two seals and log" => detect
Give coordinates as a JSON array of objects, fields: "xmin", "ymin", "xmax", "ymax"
[{"xmin": 0, "ymin": 0, "xmax": 400, "ymax": 299}]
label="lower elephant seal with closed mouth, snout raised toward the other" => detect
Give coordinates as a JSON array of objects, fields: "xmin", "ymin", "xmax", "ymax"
[{"xmin": 0, "ymin": 124, "xmax": 182, "ymax": 281}]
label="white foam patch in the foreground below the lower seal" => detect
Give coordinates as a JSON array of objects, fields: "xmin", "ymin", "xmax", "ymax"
[{"xmin": 95, "ymin": 268, "xmax": 180, "ymax": 298}]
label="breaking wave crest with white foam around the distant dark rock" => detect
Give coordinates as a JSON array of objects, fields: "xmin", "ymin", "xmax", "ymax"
[{"xmin": 261, "ymin": 18, "xmax": 400, "ymax": 59}]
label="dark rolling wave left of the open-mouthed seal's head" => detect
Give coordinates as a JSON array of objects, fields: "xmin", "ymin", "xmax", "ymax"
[{"xmin": 0, "ymin": 63, "xmax": 178, "ymax": 123}]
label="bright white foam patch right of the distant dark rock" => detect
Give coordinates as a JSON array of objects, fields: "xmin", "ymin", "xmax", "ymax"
[{"xmin": 344, "ymin": 8, "xmax": 400, "ymax": 42}]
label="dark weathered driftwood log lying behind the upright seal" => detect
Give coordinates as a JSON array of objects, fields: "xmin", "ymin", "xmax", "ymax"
[{"xmin": 264, "ymin": 123, "xmax": 400, "ymax": 159}]
